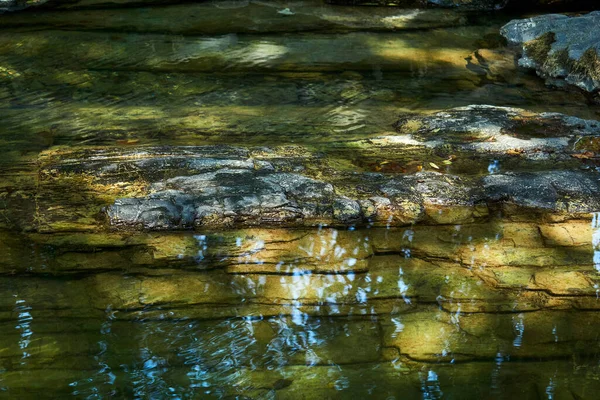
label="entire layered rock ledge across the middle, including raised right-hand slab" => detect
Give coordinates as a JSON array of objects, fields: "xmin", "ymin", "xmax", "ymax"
[{"xmin": 19, "ymin": 106, "xmax": 600, "ymax": 231}]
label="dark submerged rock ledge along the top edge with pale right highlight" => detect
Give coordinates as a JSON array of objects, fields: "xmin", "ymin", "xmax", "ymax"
[{"xmin": 0, "ymin": 0, "xmax": 468, "ymax": 35}]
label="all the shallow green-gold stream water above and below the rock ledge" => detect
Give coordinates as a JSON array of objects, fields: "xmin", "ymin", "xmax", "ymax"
[{"xmin": 0, "ymin": 0, "xmax": 600, "ymax": 400}]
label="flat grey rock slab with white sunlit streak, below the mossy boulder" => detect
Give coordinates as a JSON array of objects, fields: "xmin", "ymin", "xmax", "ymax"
[{"xmin": 390, "ymin": 105, "xmax": 600, "ymax": 162}]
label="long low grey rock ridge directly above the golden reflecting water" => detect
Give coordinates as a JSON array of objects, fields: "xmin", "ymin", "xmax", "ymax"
[{"xmin": 37, "ymin": 149, "xmax": 600, "ymax": 230}]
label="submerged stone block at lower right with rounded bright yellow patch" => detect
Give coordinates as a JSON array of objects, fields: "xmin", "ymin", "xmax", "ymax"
[{"xmin": 384, "ymin": 311, "xmax": 598, "ymax": 362}]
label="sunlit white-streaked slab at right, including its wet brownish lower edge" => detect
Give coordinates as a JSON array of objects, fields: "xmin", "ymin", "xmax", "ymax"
[{"xmin": 364, "ymin": 105, "xmax": 600, "ymax": 168}]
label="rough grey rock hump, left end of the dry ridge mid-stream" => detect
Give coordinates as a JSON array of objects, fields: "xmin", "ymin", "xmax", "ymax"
[{"xmin": 107, "ymin": 168, "xmax": 342, "ymax": 229}]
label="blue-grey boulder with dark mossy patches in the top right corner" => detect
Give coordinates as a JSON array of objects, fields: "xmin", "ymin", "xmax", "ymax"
[{"xmin": 501, "ymin": 11, "xmax": 600, "ymax": 93}]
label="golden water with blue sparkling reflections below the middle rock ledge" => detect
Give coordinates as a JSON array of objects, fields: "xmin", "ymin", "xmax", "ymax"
[{"xmin": 0, "ymin": 222, "xmax": 600, "ymax": 399}]
